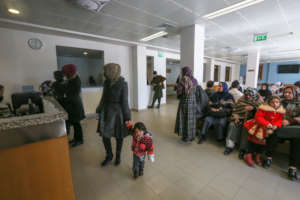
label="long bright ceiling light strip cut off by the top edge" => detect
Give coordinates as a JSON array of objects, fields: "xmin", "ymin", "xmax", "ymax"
[{"xmin": 203, "ymin": 0, "xmax": 264, "ymax": 19}]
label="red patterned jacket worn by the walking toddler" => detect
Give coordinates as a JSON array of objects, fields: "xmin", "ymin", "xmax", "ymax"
[{"xmin": 132, "ymin": 133, "xmax": 154, "ymax": 155}]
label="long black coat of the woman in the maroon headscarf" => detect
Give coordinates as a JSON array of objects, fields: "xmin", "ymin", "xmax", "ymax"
[{"xmin": 64, "ymin": 76, "xmax": 85, "ymax": 123}]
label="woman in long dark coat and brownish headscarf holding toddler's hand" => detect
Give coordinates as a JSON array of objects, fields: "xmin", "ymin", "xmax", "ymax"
[{"xmin": 96, "ymin": 63, "xmax": 131, "ymax": 166}]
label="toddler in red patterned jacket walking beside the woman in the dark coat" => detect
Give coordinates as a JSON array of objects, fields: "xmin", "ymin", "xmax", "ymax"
[{"xmin": 132, "ymin": 122, "xmax": 154, "ymax": 179}]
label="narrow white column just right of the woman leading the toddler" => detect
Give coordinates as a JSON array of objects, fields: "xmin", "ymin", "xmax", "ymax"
[{"xmin": 132, "ymin": 45, "xmax": 148, "ymax": 110}]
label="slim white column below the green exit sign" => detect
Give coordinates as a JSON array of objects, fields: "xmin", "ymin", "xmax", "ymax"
[{"xmin": 246, "ymin": 49, "xmax": 260, "ymax": 88}]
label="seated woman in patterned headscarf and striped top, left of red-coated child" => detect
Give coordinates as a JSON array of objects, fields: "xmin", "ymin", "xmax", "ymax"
[{"xmin": 224, "ymin": 88, "xmax": 263, "ymax": 155}]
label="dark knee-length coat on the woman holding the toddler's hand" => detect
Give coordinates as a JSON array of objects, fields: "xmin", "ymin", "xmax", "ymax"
[{"xmin": 97, "ymin": 77, "xmax": 131, "ymax": 138}]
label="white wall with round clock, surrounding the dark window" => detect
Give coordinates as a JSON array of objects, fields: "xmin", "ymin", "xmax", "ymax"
[{"xmin": 0, "ymin": 28, "xmax": 132, "ymax": 113}]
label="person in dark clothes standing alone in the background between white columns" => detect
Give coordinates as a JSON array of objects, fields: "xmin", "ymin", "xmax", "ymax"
[{"xmin": 148, "ymin": 71, "xmax": 166, "ymax": 108}]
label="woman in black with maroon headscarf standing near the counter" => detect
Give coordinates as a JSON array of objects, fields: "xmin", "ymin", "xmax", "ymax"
[{"xmin": 62, "ymin": 64, "xmax": 85, "ymax": 147}]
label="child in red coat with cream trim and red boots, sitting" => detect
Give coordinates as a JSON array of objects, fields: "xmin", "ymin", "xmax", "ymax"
[{"xmin": 244, "ymin": 96, "xmax": 285, "ymax": 166}]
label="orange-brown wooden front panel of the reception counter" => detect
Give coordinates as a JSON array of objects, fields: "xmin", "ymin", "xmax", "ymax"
[{"xmin": 0, "ymin": 136, "xmax": 75, "ymax": 200}]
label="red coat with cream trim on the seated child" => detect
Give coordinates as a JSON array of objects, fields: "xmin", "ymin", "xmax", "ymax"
[{"xmin": 244, "ymin": 104, "xmax": 285, "ymax": 145}]
